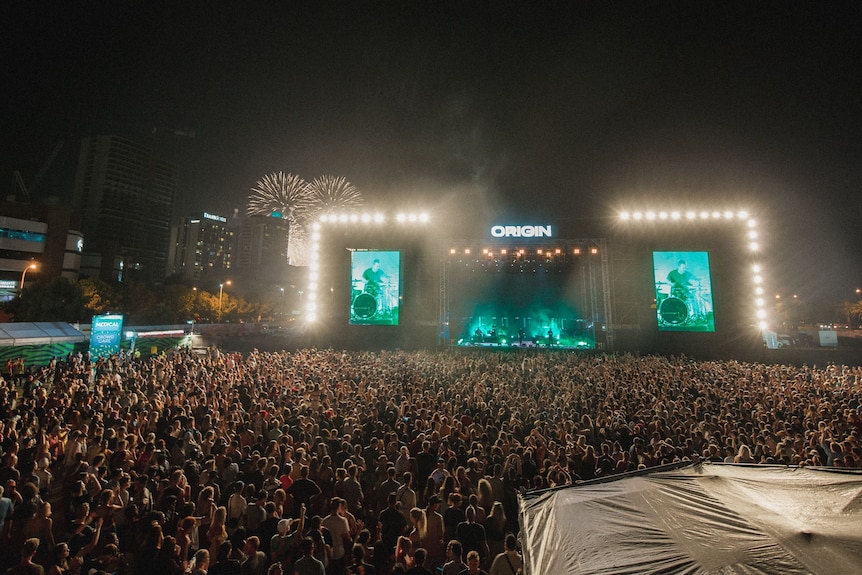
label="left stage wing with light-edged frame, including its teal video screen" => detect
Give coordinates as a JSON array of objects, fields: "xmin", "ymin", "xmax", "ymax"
[{"xmin": 305, "ymin": 213, "xmax": 438, "ymax": 349}]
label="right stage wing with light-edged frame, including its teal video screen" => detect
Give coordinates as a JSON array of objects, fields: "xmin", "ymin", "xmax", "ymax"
[{"xmin": 611, "ymin": 209, "xmax": 768, "ymax": 356}]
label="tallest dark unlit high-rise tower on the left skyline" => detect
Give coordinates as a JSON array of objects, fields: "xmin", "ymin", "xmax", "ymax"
[{"xmin": 72, "ymin": 136, "xmax": 177, "ymax": 282}]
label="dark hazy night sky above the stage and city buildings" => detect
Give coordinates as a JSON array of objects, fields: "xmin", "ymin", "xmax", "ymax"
[{"xmin": 5, "ymin": 1, "xmax": 862, "ymax": 301}]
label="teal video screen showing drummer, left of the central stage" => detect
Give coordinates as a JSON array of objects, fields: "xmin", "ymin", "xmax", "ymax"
[{"xmin": 350, "ymin": 250, "xmax": 401, "ymax": 325}]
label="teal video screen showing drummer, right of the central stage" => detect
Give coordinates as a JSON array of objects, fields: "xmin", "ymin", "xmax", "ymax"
[{"xmin": 653, "ymin": 252, "xmax": 715, "ymax": 332}]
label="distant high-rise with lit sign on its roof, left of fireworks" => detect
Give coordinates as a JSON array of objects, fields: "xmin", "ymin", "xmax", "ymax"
[{"xmin": 168, "ymin": 212, "xmax": 236, "ymax": 281}]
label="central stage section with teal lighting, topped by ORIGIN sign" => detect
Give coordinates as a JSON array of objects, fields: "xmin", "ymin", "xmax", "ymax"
[{"xmin": 446, "ymin": 234, "xmax": 613, "ymax": 349}]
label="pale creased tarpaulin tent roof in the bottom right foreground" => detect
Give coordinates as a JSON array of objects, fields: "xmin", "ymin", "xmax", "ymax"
[{"xmin": 520, "ymin": 463, "xmax": 862, "ymax": 575}]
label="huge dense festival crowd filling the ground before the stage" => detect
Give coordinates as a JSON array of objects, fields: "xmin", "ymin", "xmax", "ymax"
[{"xmin": 0, "ymin": 349, "xmax": 862, "ymax": 575}]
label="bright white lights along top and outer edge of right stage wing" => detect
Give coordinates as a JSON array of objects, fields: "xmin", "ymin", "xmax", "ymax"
[{"xmin": 619, "ymin": 210, "xmax": 769, "ymax": 331}]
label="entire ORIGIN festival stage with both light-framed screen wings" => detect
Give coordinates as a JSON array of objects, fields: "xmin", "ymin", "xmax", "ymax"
[{"xmin": 304, "ymin": 205, "xmax": 768, "ymax": 356}]
